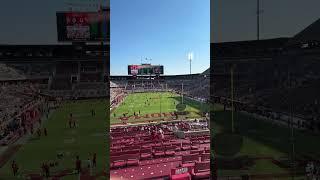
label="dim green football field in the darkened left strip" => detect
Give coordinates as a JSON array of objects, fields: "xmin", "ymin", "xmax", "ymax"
[{"xmin": 0, "ymin": 100, "xmax": 108, "ymax": 180}]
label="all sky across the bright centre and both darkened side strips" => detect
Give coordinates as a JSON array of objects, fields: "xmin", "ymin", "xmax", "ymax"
[{"xmin": 0, "ymin": 0, "xmax": 320, "ymax": 74}]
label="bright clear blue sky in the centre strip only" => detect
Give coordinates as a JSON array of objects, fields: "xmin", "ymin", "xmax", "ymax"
[{"xmin": 110, "ymin": 0, "xmax": 210, "ymax": 75}]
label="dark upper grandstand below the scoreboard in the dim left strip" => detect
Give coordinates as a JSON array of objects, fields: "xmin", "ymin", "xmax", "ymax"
[{"xmin": 0, "ymin": 44, "xmax": 109, "ymax": 98}]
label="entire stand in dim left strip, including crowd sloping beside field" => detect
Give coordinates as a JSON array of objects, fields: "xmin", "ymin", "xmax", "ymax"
[{"xmin": 0, "ymin": 45, "xmax": 108, "ymax": 150}]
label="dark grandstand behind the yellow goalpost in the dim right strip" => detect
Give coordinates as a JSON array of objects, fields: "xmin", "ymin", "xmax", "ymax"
[{"xmin": 211, "ymin": 26, "xmax": 320, "ymax": 131}]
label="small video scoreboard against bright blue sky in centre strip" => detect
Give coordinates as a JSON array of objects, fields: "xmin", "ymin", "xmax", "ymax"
[{"xmin": 128, "ymin": 64, "xmax": 163, "ymax": 75}]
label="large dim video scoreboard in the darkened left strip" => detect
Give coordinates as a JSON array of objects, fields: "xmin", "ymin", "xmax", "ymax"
[{"xmin": 57, "ymin": 10, "xmax": 110, "ymax": 41}]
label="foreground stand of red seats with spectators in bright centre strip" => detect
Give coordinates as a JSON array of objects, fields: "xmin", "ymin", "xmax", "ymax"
[{"xmin": 110, "ymin": 121, "xmax": 210, "ymax": 179}]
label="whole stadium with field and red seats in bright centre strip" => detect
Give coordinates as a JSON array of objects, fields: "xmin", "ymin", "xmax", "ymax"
[{"xmin": 110, "ymin": 64, "xmax": 210, "ymax": 179}]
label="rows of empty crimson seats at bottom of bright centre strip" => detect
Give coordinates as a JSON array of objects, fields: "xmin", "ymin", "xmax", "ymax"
[{"xmin": 110, "ymin": 122, "xmax": 210, "ymax": 179}]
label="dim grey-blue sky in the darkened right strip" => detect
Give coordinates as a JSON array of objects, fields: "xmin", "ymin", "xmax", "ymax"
[{"xmin": 211, "ymin": 0, "xmax": 320, "ymax": 42}]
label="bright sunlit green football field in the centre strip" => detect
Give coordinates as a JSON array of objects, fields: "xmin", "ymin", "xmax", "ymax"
[{"xmin": 110, "ymin": 92, "xmax": 208, "ymax": 124}]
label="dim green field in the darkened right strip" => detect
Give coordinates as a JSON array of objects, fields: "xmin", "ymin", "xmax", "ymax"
[{"xmin": 211, "ymin": 105, "xmax": 320, "ymax": 176}]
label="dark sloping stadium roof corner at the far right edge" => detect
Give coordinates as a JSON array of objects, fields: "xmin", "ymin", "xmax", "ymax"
[{"xmin": 288, "ymin": 19, "xmax": 320, "ymax": 45}]
